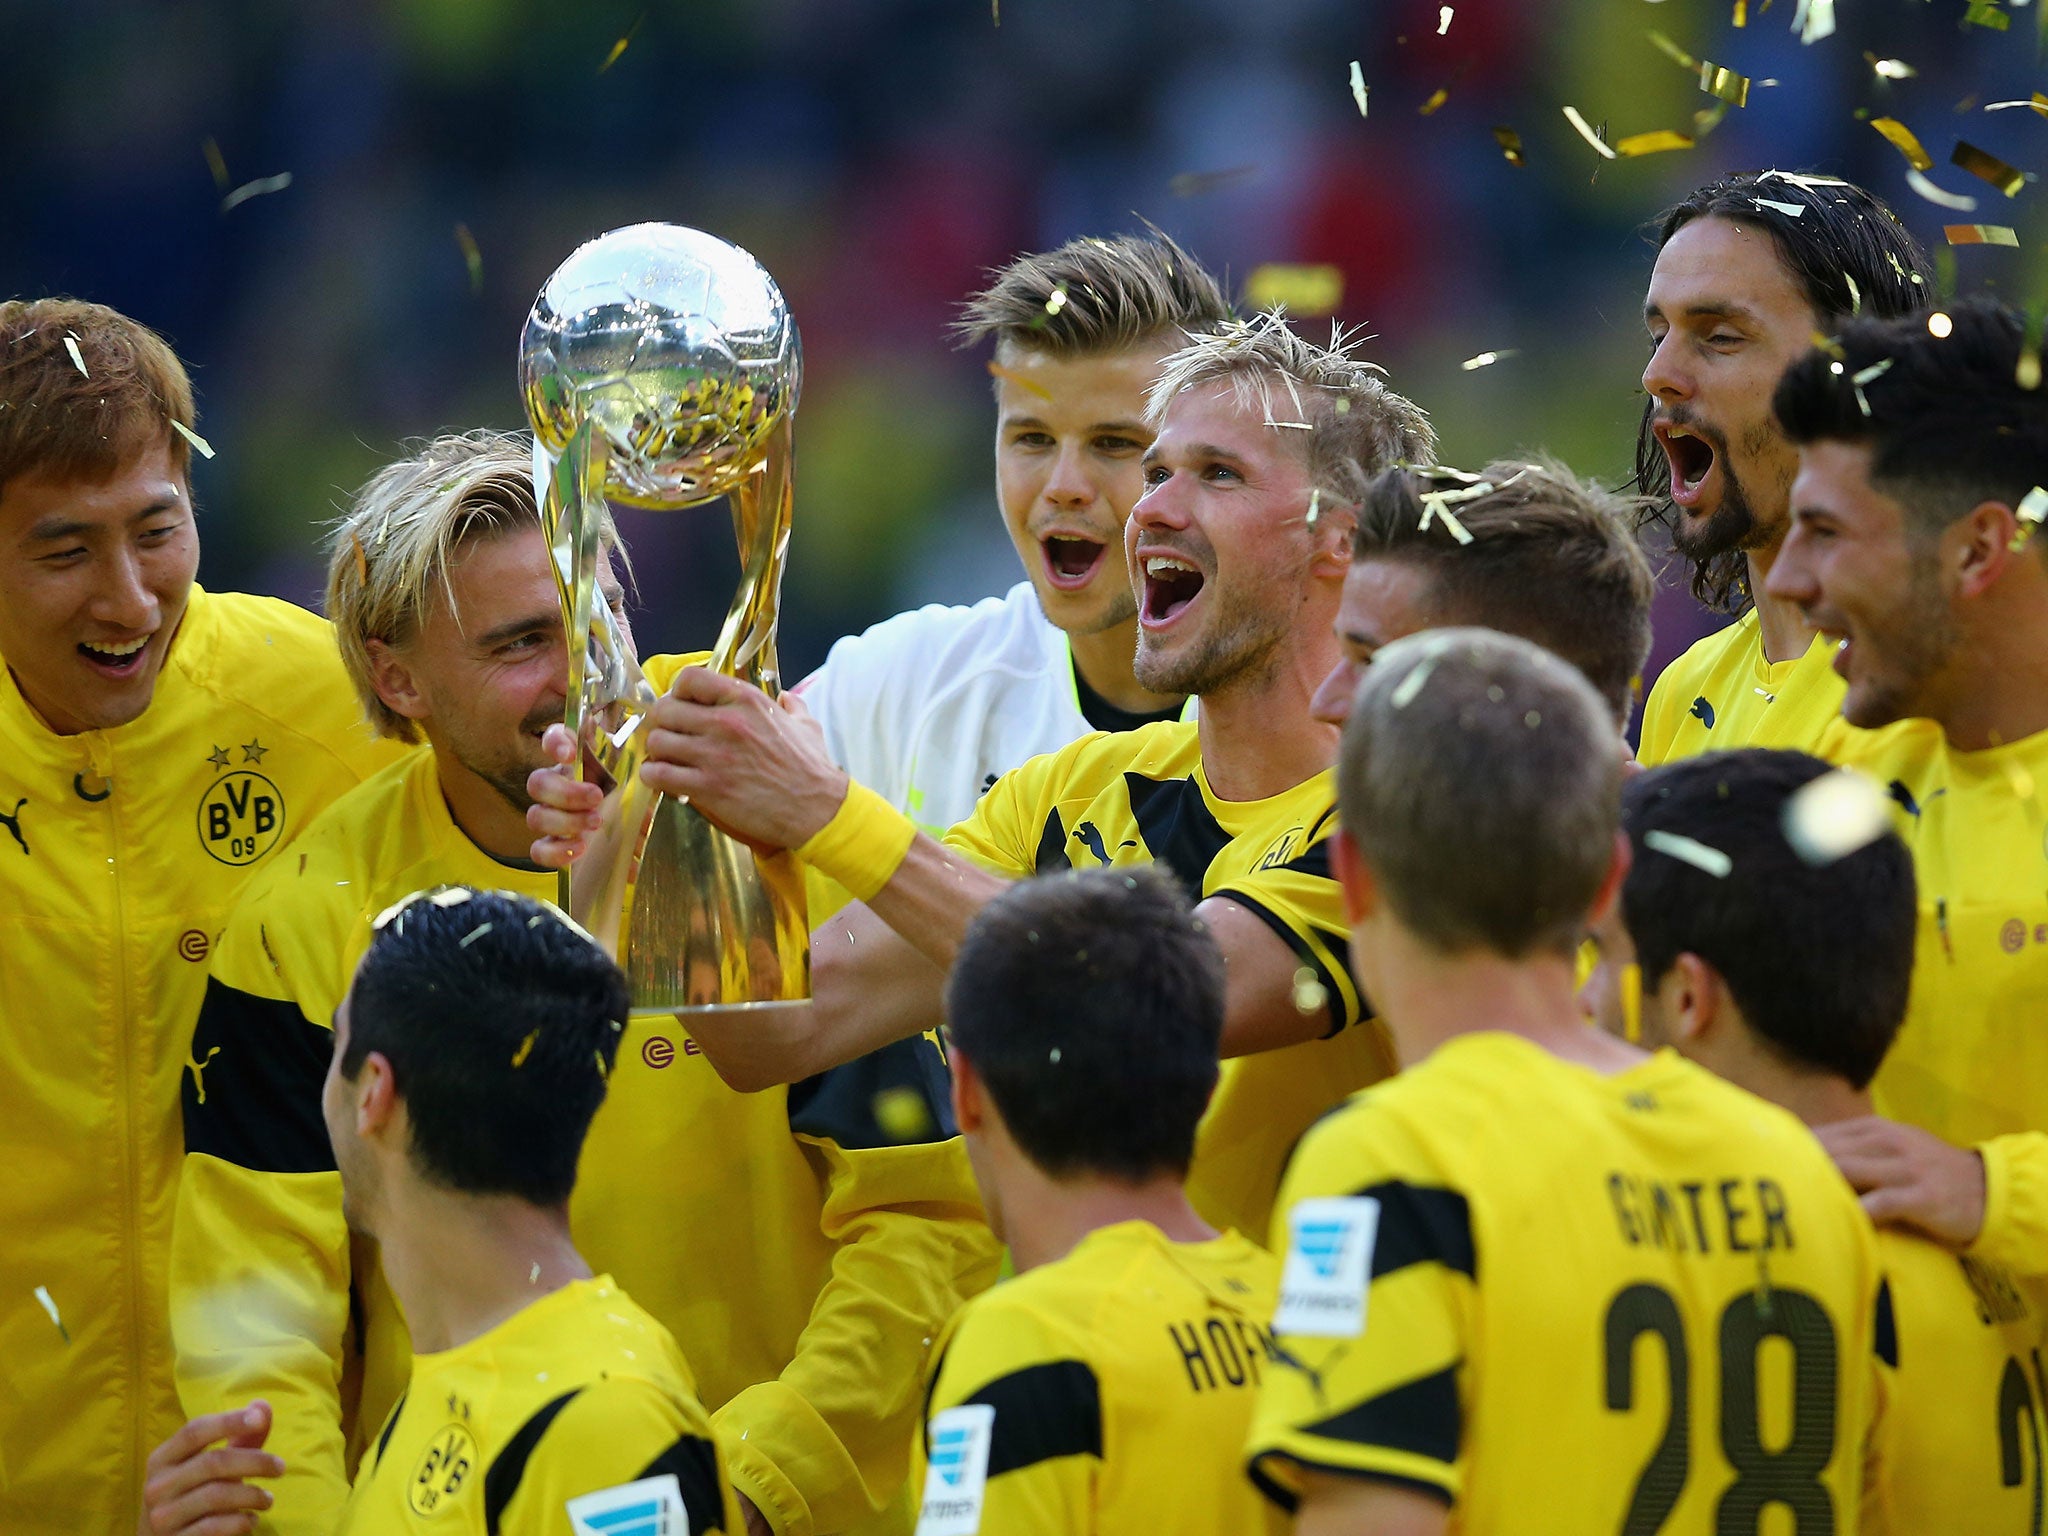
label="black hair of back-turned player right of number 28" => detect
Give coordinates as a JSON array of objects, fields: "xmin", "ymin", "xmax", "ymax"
[{"xmin": 1622, "ymin": 748, "xmax": 1917, "ymax": 1087}]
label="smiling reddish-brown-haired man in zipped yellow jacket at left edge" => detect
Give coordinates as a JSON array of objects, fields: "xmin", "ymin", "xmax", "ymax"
[{"xmin": 0, "ymin": 299, "xmax": 405, "ymax": 1532}]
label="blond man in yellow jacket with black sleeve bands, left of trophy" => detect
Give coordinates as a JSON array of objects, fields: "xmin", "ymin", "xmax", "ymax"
[{"xmin": 172, "ymin": 434, "xmax": 995, "ymax": 1536}]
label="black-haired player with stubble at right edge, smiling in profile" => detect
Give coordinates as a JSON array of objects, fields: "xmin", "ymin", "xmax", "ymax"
[{"xmin": 1769, "ymin": 303, "xmax": 2048, "ymax": 1294}]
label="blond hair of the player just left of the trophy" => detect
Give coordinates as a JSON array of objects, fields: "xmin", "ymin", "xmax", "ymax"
[{"xmin": 328, "ymin": 432, "xmax": 616, "ymax": 741}]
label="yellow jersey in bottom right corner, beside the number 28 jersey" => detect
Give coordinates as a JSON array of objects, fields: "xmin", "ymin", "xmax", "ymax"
[{"xmin": 1878, "ymin": 1231, "xmax": 2048, "ymax": 1536}]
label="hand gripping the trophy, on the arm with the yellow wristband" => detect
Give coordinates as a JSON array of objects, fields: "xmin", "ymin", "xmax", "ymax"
[{"xmin": 641, "ymin": 668, "xmax": 848, "ymax": 848}]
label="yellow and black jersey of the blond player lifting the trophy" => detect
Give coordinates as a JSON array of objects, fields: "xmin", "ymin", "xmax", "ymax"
[{"xmin": 946, "ymin": 721, "xmax": 1393, "ymax": 1233}]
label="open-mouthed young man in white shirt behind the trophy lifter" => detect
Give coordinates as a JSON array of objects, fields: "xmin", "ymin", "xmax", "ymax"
[{"xmin": 799, "ymin": 236, "xmax": 1229, "ymax": 838}]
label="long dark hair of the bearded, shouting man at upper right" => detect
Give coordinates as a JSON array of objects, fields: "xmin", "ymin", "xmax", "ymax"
[{"xmin": 1636, "ymin": 170, "xmax": 1935, "ymax": 612}]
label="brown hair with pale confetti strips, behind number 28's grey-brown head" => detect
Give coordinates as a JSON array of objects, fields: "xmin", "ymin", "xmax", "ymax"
[{"xmin": 1352, "ymin": 461, "xmax": 1657, "ymax": 727}]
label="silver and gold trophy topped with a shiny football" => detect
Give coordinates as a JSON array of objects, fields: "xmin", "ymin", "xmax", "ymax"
[{"xmin": 520, "ymin": 223, "xmax": 811, "ymax": 1016}]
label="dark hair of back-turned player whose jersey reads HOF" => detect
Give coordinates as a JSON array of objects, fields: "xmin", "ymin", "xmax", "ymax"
[{"xmin": 946, "ymin": 866, "xmax": 1223, "ymax": 1184}]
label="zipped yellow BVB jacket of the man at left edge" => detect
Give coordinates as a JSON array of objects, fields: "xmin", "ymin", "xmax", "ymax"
[{"xmin": 0, "ymin": 586, "xmax": 401, "ymax": 1536}]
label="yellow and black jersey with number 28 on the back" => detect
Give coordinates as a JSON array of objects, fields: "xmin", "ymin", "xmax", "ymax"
[{"xmin": 1249, "ymin": 1032, "xmax": 1880, "ymax": 1536}]
